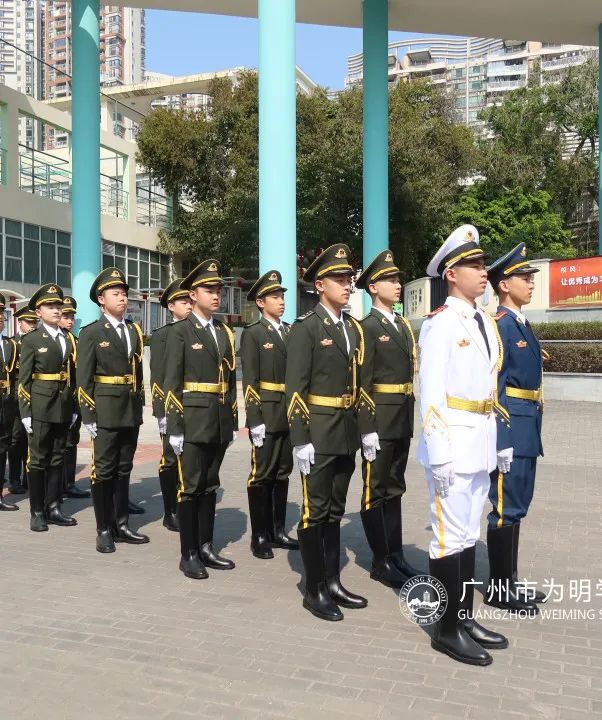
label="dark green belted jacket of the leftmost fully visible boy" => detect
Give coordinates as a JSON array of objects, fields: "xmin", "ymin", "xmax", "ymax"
[{"xmin": 18, "ymin": 326, "xmax": 76, "ymax": 424}]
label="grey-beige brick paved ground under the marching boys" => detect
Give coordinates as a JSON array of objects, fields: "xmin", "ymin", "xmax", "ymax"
[{"xmin": 0, "ymin": 402, "xmax": 602, "ymax": 720}]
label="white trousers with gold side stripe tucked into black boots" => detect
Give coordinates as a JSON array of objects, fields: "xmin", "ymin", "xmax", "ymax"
[{"xmin": 424, "ymin": 468, "xmax": 490, "ymax": 559}]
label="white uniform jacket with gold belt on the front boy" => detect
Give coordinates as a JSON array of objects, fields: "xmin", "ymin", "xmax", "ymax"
[{"xmin": 418, "ymin": 297, "xmax": 502, "ymax": 473}]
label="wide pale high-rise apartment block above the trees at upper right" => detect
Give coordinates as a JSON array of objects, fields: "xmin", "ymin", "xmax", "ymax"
[{"xmin": 345, "ymin": 37, "xmax": 597, "ymax": 125}]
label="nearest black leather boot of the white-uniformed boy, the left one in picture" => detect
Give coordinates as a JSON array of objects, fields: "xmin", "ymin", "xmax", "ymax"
[{"xmin": 429, "ymin": 553, "xmax": 493, "ymax": 665}]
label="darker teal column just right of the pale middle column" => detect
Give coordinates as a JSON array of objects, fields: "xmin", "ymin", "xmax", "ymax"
[{"xmin": 363, "ymin": 0, "xmax": 389, "ymax": 306}]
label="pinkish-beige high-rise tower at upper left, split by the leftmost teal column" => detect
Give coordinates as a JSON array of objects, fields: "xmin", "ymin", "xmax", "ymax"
[{"xmin": 42, "ymin": 0, "xmax": 145, "ymax": 147}]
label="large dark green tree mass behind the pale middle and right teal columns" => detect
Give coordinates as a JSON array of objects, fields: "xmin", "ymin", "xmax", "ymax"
[{"xmin": 138, "ymin": 73, "xmax": 475, "ymax": 278}]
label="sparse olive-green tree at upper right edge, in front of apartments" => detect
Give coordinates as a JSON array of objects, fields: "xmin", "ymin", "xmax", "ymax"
[{"xmin": 479, "ymin": 59, "xmax": 598, "ymax": 231}]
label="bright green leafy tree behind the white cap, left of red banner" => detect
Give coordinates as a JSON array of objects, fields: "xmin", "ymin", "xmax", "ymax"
[{"xmin": 450, "ymin": 183, "xmax": 576, "ymax": 260}]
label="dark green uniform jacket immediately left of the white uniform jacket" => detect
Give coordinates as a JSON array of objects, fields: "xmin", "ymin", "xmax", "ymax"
[{"xmin": 358, "ymin": 308, "xmax": 416, "ymax": 440}]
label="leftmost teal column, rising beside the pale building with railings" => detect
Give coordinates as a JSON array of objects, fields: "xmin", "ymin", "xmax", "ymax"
[{"xmin": 71, "ymin": 0, "xmax": 101, "ymax": 325}]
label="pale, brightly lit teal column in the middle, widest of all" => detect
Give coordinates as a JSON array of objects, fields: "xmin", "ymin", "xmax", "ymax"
[{"xmin": 258, "ymin": 0, "xmax": 297, "ymax": 322}]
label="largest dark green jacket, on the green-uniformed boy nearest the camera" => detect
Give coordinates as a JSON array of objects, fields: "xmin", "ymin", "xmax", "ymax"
[{"xmin": 286, "ymin": 304, "xmax": 364, "ymax": 455}]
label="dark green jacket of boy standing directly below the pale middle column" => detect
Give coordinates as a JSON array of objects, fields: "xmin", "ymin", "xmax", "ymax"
[{"xmin": 240, "ymin": 317, "xmax": 289, "ymax": 433}]
